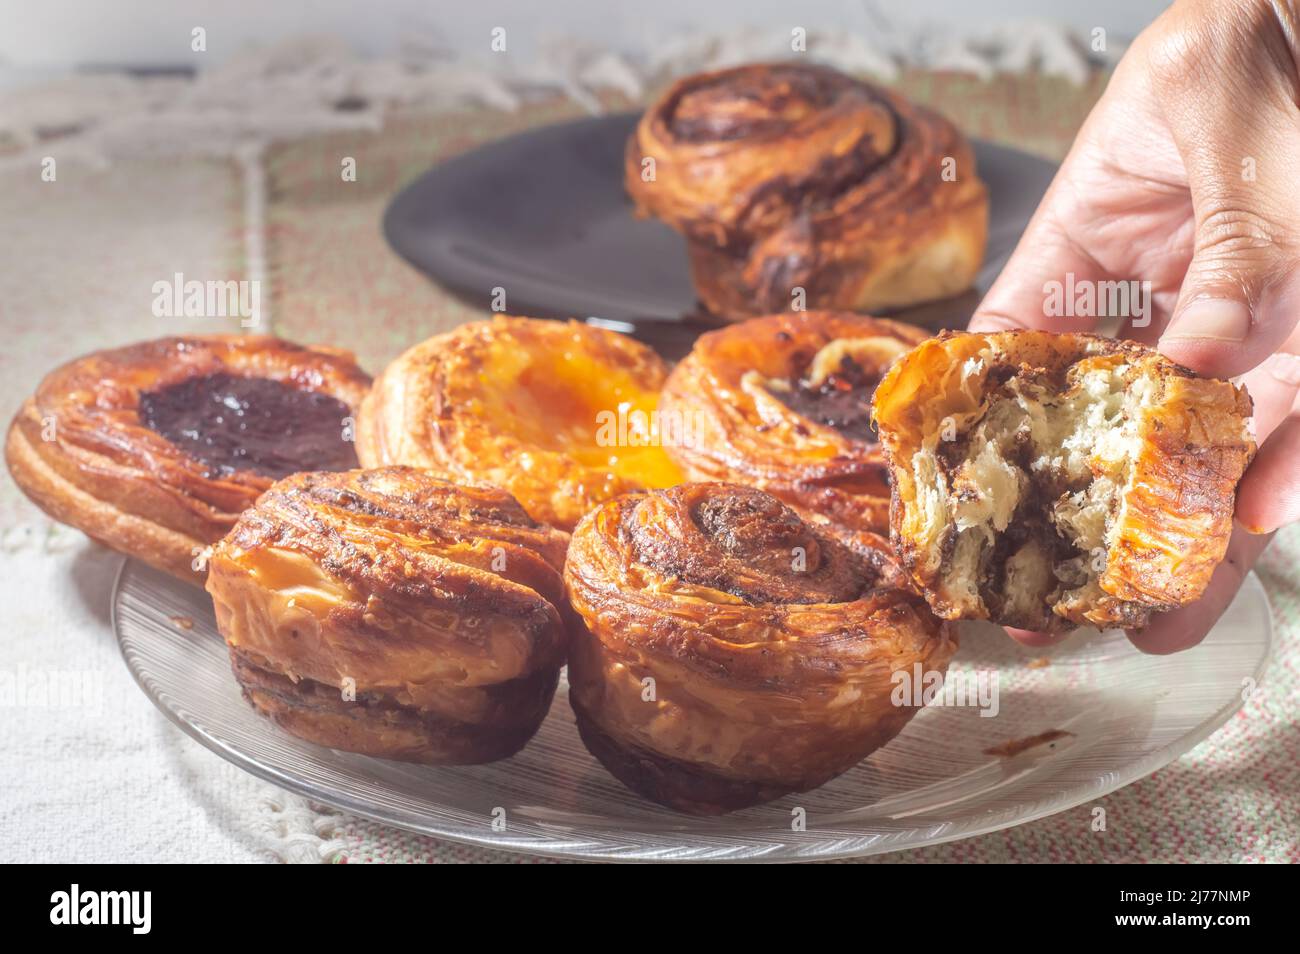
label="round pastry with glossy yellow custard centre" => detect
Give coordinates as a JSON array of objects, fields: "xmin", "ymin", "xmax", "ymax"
[{"xmin": 356, "ymin": 316, "xmax": 681, "ymax": 530}]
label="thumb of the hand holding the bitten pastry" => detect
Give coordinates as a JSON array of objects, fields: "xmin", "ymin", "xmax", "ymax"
[{"xmin": 1147, "ymin": 3, "xmax": 1300, "ymax": 377}]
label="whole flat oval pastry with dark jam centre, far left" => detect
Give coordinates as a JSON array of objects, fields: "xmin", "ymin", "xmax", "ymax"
[{"xmin": 5, "ymin": 335, "xmax": 369, "ymax": 581}]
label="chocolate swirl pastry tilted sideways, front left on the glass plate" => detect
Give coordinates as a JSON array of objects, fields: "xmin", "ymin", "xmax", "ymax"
[{"xmin": 207, "ymin": 467, "xmax": 568, "ymax": 764}]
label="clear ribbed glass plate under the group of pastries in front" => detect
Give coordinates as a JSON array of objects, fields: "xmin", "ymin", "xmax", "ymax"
[{"xmin": 113, "ymin": 560, "xmax": 1271, "ymax": 860}]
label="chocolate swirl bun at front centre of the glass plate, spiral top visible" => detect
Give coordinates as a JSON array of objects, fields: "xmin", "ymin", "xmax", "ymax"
[{"xmin": 564, "ymin": 483, "xmax": 956, "ymax": 814}]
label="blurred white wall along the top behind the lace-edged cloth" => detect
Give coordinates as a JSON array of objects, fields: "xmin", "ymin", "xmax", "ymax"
[{"xmin": 0, "ymin": 0, "xmax": 1166, "ymax": 70}]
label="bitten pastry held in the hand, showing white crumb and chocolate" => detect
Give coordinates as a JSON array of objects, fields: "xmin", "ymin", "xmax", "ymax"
[{"xmin": 875, "ymin": 331, "xmax": 1255, "ymax": 632}]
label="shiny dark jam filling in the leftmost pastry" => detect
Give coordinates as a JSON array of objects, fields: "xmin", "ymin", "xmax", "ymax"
[{"xmin": 140, "ymin": 373, "xmax": 358, "ymax": 480}]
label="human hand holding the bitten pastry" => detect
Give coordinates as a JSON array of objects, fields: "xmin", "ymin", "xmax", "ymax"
[{"xmin": 971, "ymin": 0, "xmax": 1300, "ymax": 652}]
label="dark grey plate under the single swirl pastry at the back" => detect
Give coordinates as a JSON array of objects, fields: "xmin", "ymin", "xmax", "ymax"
[{"xmin": 384, "ymin": 113, "xmax": 1056, "ymax": 354}]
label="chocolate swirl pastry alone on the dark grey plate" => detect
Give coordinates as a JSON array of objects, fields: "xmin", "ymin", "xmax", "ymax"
[{"xmin": 624, "ymin": 64, "xmax": 988, "ymax": 320}]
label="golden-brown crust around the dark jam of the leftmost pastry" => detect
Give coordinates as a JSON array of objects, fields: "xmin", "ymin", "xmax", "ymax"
[{"xmin": 5, "ymin": 335, "xmax": 369, "ymax": 582}]
